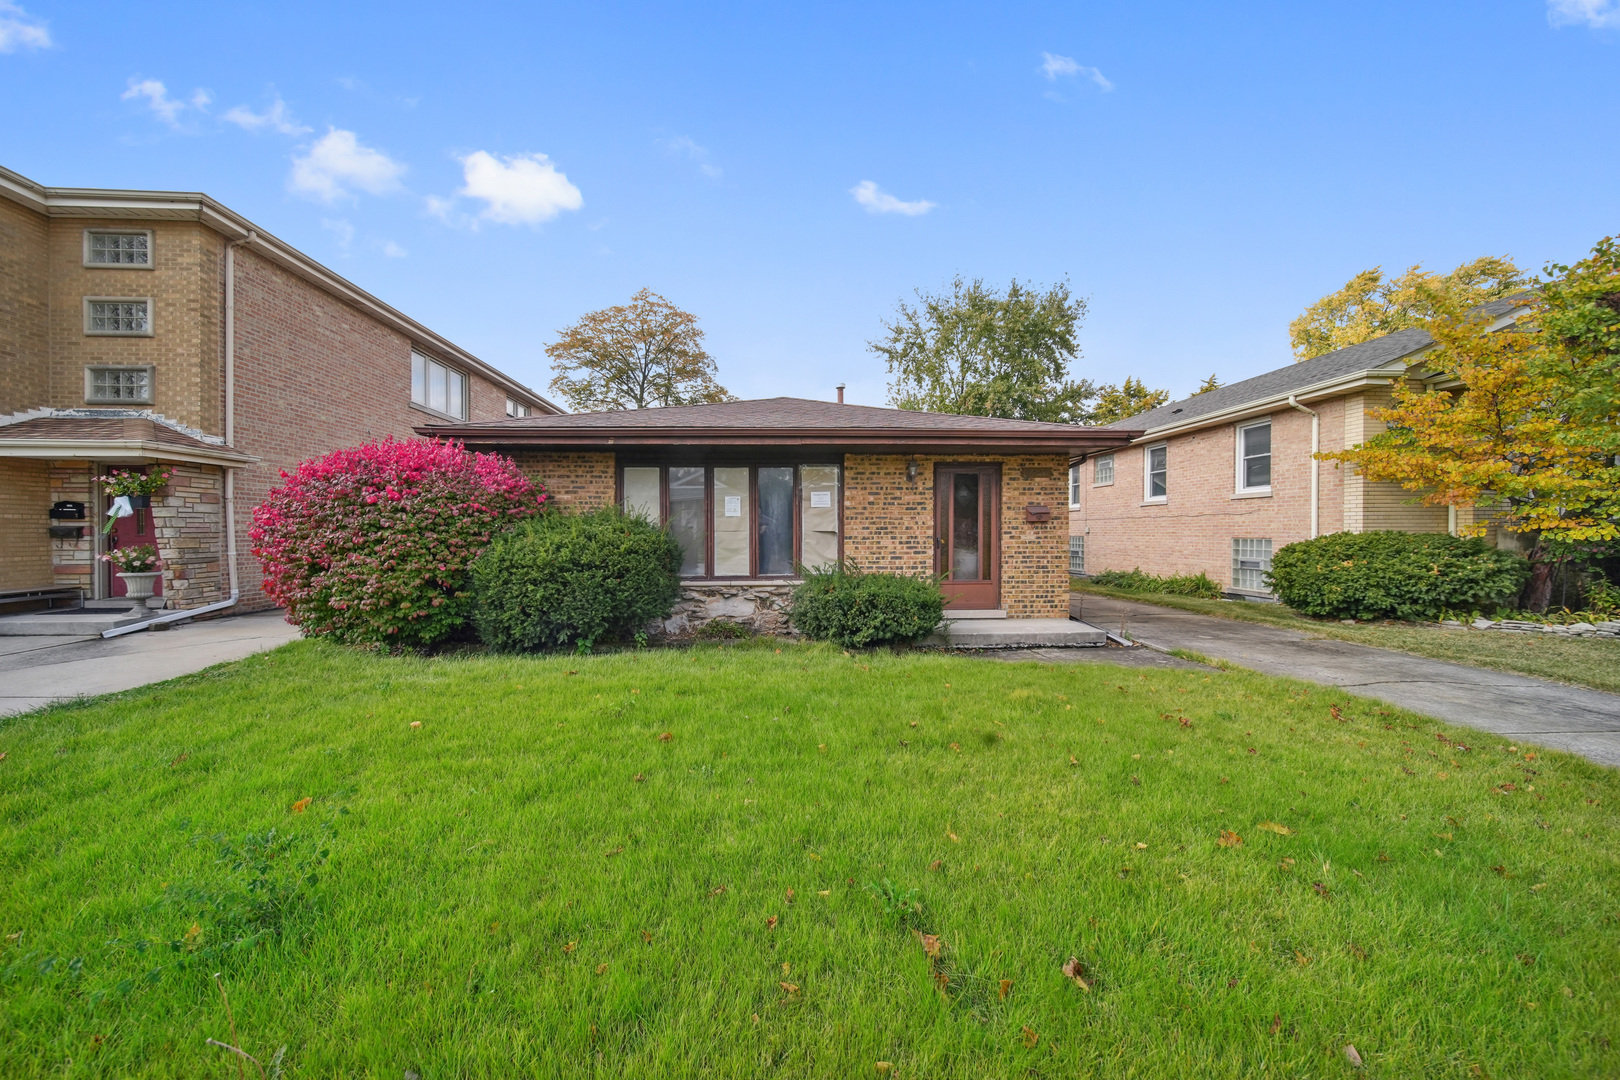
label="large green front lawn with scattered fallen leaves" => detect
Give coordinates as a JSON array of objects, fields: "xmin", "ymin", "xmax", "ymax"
[{"xmin": 0, "ymin": 643, "xmax": 1620, "ymax": 1080}]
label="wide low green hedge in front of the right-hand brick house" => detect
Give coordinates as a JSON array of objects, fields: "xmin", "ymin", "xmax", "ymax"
[{"xmin": 1267, "ymin": 531, "xmax": 1529, "ymax": 620}]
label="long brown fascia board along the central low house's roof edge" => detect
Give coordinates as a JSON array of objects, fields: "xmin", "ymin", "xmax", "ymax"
[{"xmin": 416, "ymin": 424, "xmax": 1142, "ymax": 457}]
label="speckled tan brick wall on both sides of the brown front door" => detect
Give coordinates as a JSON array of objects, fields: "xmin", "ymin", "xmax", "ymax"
[{"xmin": 844, "ymin": 453, "xmax": 1069, "ymax": 619}]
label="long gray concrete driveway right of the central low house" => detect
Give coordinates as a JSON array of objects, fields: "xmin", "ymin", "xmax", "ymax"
[{"xmin": 1071, "ymin": 594, "xmax": 1620, "ymax": 766}]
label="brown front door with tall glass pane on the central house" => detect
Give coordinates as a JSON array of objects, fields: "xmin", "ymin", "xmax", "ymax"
[{"xmin": 933, "ymin": 465, "xmax": 1001, "ymax": 610}]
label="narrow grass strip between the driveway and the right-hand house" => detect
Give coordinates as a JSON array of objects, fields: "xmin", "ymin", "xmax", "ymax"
[{"xmin": 1071, "ymin": 578, "xmax": 1620, "ymax": 693}]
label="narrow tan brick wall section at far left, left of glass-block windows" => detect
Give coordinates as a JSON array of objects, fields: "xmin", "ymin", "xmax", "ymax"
[{"xmin": 0, "ymin": 199, "xmax": 50, "ymax": 416}]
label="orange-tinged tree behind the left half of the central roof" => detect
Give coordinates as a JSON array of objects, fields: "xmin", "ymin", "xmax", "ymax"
[{"xmin": 546, "ymin": 288, "xmax": 737, "ymax": 413}]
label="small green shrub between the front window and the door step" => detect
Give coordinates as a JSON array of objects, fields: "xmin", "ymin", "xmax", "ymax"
[{"xmin": 787, "ymin": 563, "xmax": 944, "ymax": 648}]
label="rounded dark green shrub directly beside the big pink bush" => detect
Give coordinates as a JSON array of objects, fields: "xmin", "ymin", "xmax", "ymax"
[{"xmin": 473, "ymin": 507, "xmax": 680, "ymax": 653}]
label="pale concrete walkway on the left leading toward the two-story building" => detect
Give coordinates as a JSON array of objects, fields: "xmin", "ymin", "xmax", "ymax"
[{"xmin": 0, "ymin": 610, "xmax": 298, "ymax": 716}]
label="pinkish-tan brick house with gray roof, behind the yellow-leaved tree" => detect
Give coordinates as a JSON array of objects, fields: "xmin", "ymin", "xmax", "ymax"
[{"xmin": 1069, "ymin": 298, "xmax": 1528, "ymax": 599}]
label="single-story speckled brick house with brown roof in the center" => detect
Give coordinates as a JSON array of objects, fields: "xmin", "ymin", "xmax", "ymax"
[{"xmin": 418, "ymin": 389, "xmax": 1128, "ymax": 633}]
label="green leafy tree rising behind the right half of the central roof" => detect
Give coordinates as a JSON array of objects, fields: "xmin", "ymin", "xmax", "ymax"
[{"xmin": 868, "ymin": 277, "xmax": 1095, "ymax": 424}]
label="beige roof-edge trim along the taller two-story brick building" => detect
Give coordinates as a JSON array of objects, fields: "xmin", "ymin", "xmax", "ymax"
[{"xmin": 0, "ymin": 165, "xmax": 564, "ymax": 415}]
